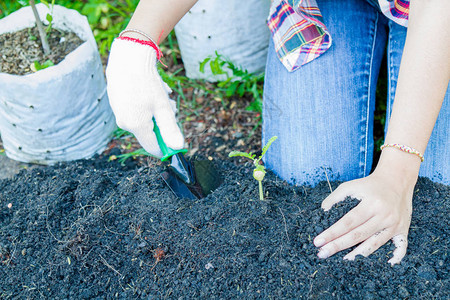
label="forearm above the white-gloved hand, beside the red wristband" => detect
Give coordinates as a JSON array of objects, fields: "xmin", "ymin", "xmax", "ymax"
[{"xmin": 122, "ymin": 0, "xmax": 197, "ymax": 42}]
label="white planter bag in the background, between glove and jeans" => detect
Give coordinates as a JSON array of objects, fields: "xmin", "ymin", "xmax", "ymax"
[{"xmin": 175, "ymin": 0, "xmax": 270, "ymax": 81}]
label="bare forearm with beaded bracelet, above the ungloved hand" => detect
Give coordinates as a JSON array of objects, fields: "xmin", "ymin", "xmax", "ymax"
[{"xmin": 380, "ymin": 0, "xmax": 450, "ymax": 177}]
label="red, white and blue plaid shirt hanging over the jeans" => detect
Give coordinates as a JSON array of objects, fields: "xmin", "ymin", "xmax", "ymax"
[{"xmin": 267, "ymin": 0, "xmax": 409, "ymax": 72}]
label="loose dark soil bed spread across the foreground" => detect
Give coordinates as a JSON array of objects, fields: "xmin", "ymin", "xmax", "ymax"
[{"xmin": 0, "ymin": 154, "xmax": 450, "ymax": 299}]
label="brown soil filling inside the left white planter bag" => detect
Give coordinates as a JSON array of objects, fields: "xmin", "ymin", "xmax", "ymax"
[{"xmin": 0, "ymin": 26, "xmax": 83, "ymax": 75}]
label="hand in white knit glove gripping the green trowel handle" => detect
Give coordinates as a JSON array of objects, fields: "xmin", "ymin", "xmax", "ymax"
[{"xmin": 106, "ymin": 38, "xmax": 184, "ymax": 157}]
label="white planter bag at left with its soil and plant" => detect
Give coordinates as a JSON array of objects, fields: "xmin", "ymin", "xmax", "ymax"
[{"xmin": 0, "ymin": 0, "xmax": 116, "ymax": 164}]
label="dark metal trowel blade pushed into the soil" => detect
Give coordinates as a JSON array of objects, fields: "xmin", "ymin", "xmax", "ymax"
[{"xmin": 161, "ymin": 158, "xmax": 223, "ymax": 200}]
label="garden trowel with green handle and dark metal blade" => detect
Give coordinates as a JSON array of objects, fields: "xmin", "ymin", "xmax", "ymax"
[{"xmin": 153, "ymin": 119, "xmax": 222, "ymax": 199}]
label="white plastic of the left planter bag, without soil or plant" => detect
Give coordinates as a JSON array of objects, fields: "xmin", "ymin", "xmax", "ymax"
[{"xmin": 0, "ymin": 4, "xmax": 116, "ymax": 164}]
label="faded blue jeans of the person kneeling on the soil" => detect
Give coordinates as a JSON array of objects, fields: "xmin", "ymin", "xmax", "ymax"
[{"xmin": 263, "ymin": 0, "xmax": 450, "ymax": 186}]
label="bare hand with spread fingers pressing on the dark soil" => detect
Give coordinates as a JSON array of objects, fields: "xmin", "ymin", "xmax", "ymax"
[{"xmin": 314, "ymin": 172, "xmax": 415, "ymax": 265}]
